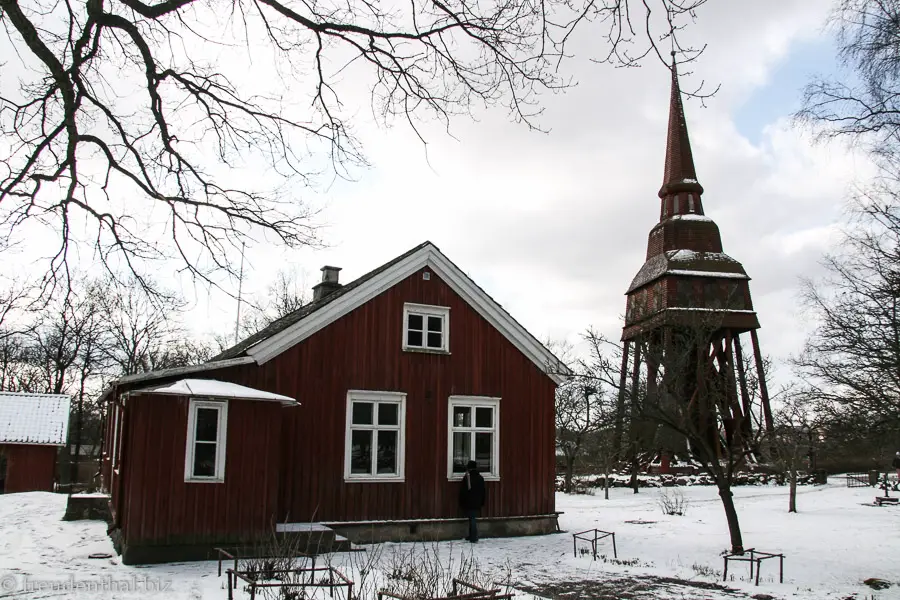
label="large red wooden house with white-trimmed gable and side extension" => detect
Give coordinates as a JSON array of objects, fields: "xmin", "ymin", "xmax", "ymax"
[{"xmin": 104, "ymin": 242, "xmax": 567, "ymax": 562}]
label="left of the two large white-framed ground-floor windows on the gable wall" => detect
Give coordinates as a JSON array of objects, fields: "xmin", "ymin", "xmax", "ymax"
[{"xmin": 344, "ymin": 390, "xmax": 406, "ymax": 481}]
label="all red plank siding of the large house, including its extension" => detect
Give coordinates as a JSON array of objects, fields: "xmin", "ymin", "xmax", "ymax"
[{"xmin": 108, "ymin": 269, "xmax": 556, "ymax": 544}]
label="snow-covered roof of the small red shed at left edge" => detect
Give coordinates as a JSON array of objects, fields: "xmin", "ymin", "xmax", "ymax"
[{"xmin": 0, "ymin": 392, "xmax": 69, "ymax": 446}]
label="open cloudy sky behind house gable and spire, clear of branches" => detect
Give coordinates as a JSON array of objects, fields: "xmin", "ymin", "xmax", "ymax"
[{"xmin": 5, "ymin": 0, "xmax": 870, "ymax": 390}]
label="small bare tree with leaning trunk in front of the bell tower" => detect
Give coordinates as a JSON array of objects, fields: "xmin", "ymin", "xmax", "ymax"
[{"xmin": 633, "ymin": 314, "xmax": 761, "ymax": 553}]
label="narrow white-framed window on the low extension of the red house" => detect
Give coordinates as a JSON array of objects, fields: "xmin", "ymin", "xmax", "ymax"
[{"xmin": 184, "ymin": 399, "xmax": 228, "ymax": 482}]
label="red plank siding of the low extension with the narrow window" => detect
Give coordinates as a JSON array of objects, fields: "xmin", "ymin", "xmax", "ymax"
[{"xmin": 119, "ymin": 395, "xmax": 282, "ymax": 544}]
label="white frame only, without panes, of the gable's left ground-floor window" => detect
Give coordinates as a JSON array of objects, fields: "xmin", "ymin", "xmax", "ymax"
[{"xmin": 344, "ymin": 390, "xmax": 406, "ymax": 483}]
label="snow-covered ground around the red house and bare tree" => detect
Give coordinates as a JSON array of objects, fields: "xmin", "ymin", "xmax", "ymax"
[{"xmin": 0, "ymin": 478, "xmax": 900, "ymax": 600}]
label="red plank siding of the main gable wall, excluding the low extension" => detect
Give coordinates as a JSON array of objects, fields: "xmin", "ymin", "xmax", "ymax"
[{"xmin": 209, "ymin": 271, "xmax": 555, "ymax": 521}]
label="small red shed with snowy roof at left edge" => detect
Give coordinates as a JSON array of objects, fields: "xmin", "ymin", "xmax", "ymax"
[{"xmin": 0, "ymin": 392, "xmax": 69, "ymax": 494}]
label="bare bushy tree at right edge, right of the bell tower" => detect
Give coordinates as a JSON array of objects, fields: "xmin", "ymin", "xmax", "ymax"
[{"xmin": 794, "ymin": 195, "xmax": 900, "ymax": 432}]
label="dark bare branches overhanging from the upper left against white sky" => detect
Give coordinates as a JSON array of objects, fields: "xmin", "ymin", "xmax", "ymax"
[{"xmin": 0, "ymin": 0, "xmax": 706, "ymax": 300}]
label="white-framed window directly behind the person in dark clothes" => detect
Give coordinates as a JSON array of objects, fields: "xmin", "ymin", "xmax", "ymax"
[{"xmin": 447, "ymin": 396, "xmax": 500, "ymax": 479}]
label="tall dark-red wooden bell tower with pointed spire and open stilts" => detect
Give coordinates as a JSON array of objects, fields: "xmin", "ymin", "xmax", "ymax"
[{"xmin": 619, "ymin": 59, "xmax": 772, "ymax": 462}]
